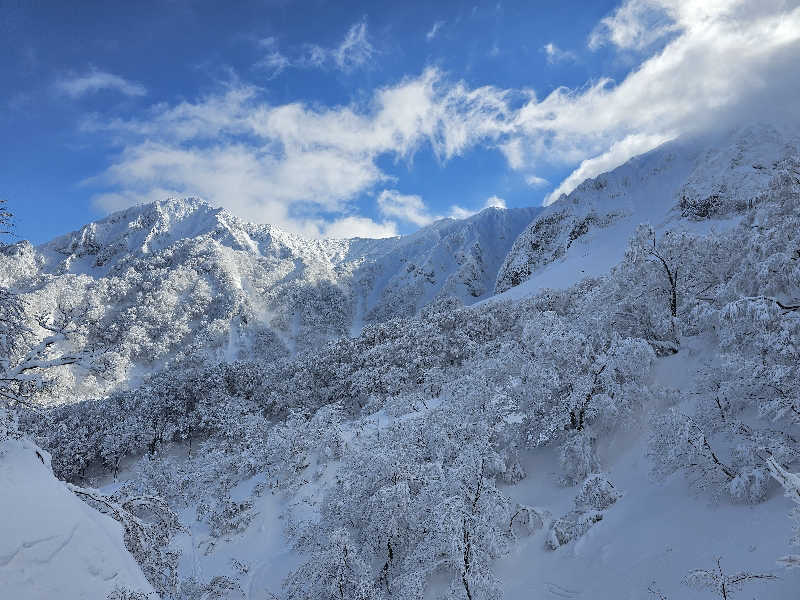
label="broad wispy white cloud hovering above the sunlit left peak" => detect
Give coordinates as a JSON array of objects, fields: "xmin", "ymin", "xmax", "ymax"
[{"xmin": 84, "ymin": 69, "xmax": 510, "ymax": 237}]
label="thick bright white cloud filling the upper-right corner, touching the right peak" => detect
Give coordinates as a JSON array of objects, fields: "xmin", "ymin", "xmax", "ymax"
[{"xmin": 520, "ymin": 0, "xmax": 800, "ymax": 201}]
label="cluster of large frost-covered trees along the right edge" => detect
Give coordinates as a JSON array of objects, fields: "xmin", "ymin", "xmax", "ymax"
[{"xmin": 651, "ymin": 165, "xmax": 800, "ymax": 502}]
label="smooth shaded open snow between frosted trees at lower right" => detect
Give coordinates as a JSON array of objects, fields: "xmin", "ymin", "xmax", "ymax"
[{"xmin": 498, "ymin": 338, "xmax": 798, "ymax": 600}]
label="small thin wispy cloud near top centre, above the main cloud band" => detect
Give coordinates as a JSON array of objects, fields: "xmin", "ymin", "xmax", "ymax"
[{"xmin": 255, "ymin": 21, "xmax": 375, "ymax": 79}]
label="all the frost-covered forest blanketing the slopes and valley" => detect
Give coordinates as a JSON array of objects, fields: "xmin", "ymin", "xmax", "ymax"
[{"xmin": 7, "ymin": 157, "xmax": 800, "ymax": 600}]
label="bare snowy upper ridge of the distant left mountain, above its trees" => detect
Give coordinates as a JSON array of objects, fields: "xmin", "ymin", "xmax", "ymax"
[{"xmin": 37, "ymin": 198, "xmax": 540, "ymax": 315}]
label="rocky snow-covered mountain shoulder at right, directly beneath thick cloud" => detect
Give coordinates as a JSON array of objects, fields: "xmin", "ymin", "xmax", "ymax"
[{"xmin": 495, "ymin": 125, "xmax": 800, "ymax": 297}]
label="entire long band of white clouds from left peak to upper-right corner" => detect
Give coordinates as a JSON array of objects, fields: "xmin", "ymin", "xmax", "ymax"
[{"xmin": 85, "ymin": 0, "xmax": 800, "ymax": 236}]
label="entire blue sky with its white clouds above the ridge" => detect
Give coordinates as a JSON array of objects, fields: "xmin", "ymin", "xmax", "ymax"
[{"xmin": 0, "ymin": 0, "xmax": 800, "ymax": 242}]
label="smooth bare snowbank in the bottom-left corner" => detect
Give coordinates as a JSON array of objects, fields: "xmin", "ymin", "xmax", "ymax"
[{"xmin": 0, "ymin": 439, "xmax": 152, "ymax": 600}]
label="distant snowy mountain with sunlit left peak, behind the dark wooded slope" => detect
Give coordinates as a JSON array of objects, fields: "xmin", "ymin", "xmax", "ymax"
[{"xmin": 0, "ymin": 199, "xmax": 540, "ymax": 396}]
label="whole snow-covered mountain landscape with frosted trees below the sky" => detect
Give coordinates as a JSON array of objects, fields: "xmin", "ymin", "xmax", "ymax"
[{"xmin": 0, "ymin": 125, "xmax": 800, "ymax": 600}]
